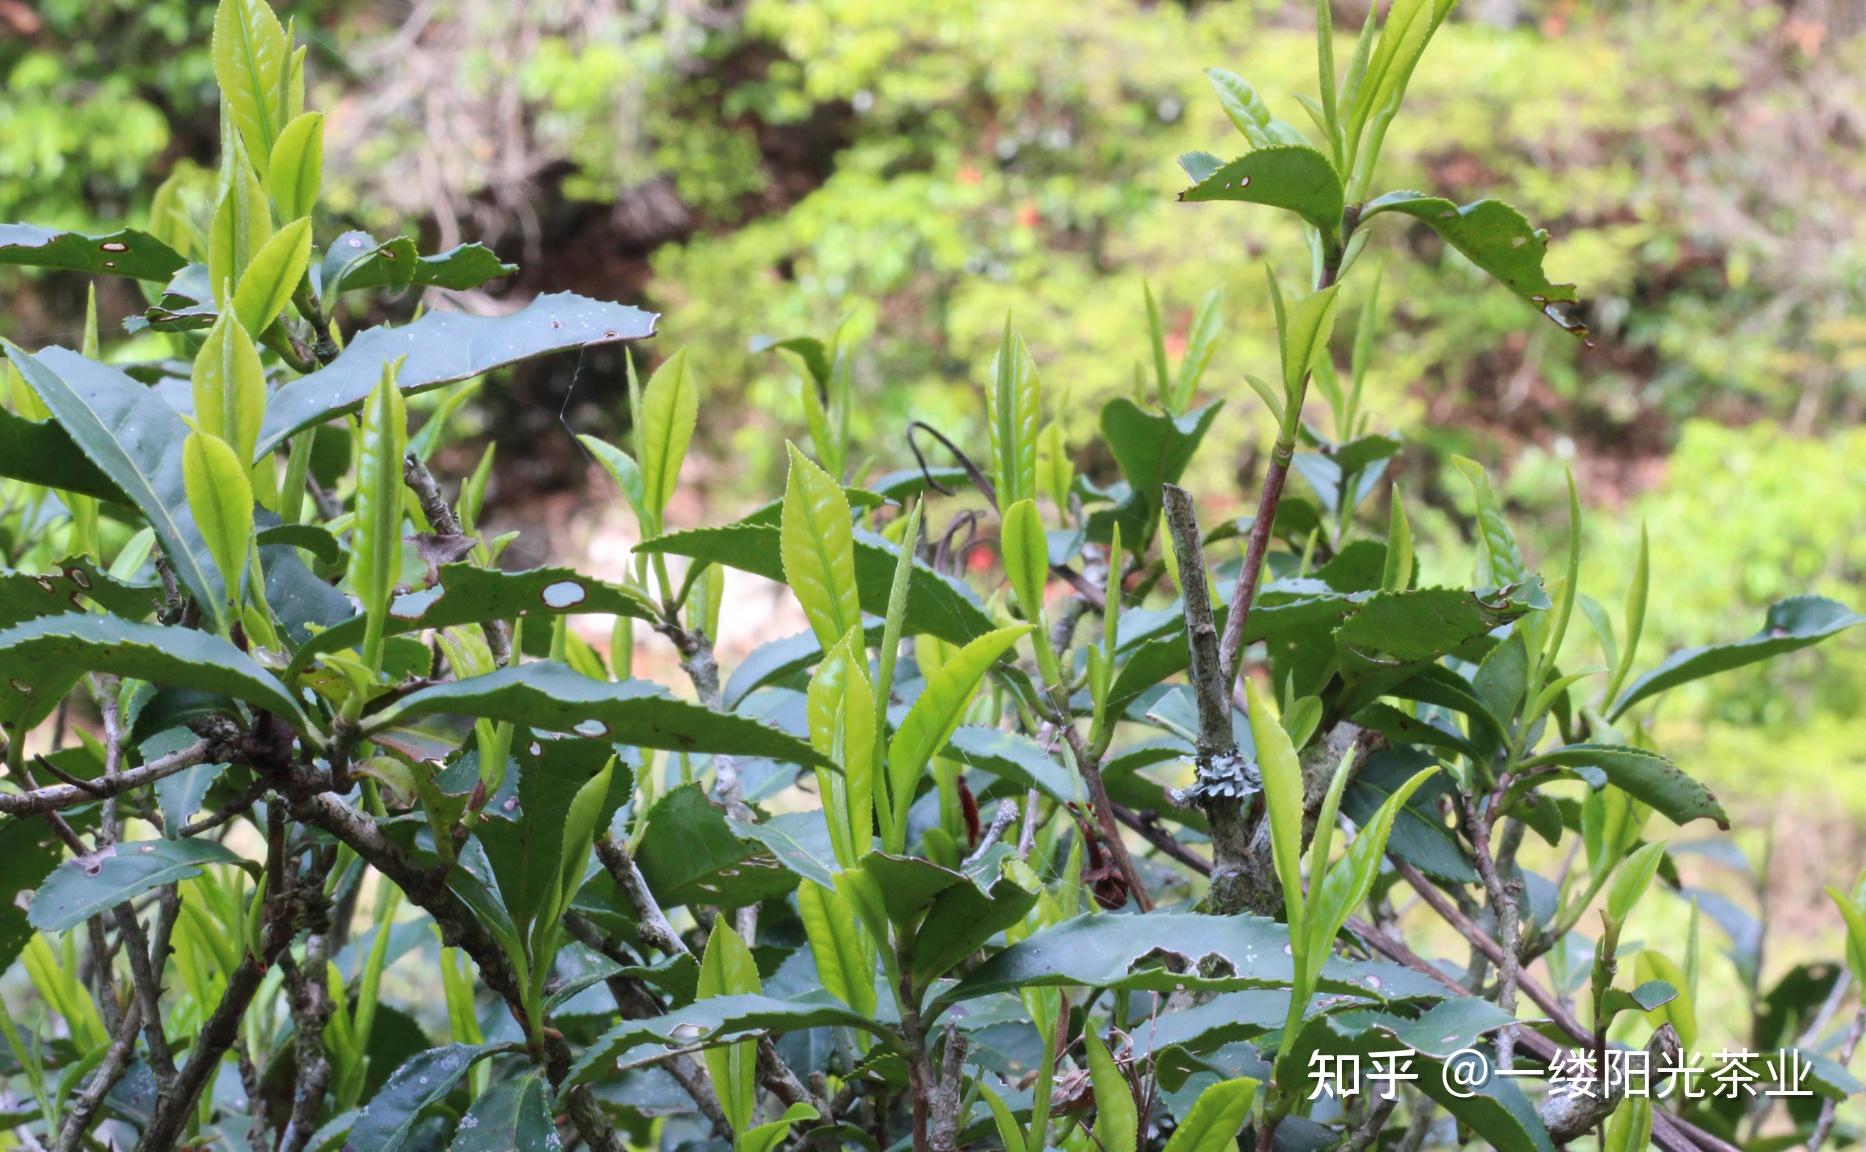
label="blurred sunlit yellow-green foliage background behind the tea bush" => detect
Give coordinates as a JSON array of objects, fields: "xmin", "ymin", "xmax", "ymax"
[{"xmin": 0, "ymin": 0, "xmax": 1866, "ymax": 820}]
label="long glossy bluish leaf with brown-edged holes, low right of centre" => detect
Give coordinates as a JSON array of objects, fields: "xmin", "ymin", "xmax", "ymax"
[{"xmin": 940, "ymin": 911, "xmax": 1444, "ymax": 1003}]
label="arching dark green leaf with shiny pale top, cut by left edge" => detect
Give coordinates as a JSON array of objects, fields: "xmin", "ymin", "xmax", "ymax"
[{"xmin": 0, "ymin": 614, "xmax": 308, "ymax": 732}]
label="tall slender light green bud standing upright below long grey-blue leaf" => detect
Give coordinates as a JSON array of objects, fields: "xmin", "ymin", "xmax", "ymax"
[{"xmin": 349, "ymin": 364, "xmax": 409, "ymax": 668}]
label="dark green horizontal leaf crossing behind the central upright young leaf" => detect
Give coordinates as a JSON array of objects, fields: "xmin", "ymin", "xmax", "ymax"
[{"xmin": 636, "ymin": 521, "xmax": 995, "ymax": 644}]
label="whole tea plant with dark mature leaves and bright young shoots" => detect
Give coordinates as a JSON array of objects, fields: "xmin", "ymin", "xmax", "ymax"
[{"xmin": 0, "ymin": 0, "xmax": 1866, "ymax": 1152}]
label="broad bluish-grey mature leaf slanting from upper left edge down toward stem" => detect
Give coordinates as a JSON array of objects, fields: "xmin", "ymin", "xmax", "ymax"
[{"xmin": 7, "ymin": 345, "xmax": 226, "ymax": 611}]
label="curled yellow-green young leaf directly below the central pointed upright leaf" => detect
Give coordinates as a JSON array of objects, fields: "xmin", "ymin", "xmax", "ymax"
[{"xmin": 804, "ymin": 629, "xmax": 879, "ymax": 868}]
